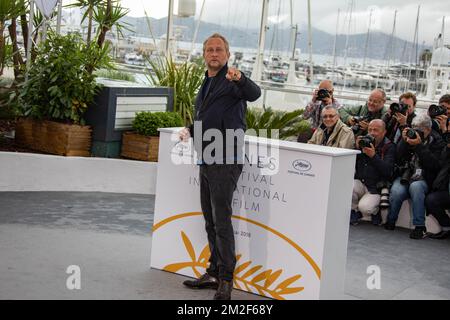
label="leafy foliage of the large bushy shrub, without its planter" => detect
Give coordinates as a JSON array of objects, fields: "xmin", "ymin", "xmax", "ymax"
[{"xmin": 13, "ymin": 33, "xmax": 111, "ymax": 124}]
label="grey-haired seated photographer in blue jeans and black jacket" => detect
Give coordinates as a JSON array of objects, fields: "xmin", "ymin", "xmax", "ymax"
[{"xmin": 385, "ymin": 114, "xmax": 444, "ymax": 239}]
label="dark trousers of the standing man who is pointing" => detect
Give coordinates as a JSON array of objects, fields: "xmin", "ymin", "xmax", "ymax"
[{"xmin": 200, "ymin": 164, "xmax": 243, "ymax": 281}]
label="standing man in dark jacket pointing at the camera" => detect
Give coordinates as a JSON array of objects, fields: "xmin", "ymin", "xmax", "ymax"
[{"xmin": 180, "ymin": 34, "xmax": 261, "ymax": 300}]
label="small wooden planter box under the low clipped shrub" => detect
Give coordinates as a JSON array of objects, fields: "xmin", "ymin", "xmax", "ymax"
[{"xmin": 121, "ymin": 132, "xmax": 159, "ymax": 162}]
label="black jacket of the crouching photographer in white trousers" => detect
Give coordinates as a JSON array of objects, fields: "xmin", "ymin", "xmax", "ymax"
[{"xmin": 355, "ymin": 138, "xmax": 395, "ymax": 194}]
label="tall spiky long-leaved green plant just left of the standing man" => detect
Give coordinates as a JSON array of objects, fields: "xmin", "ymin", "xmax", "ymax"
[{"xmin": 148, "ymin": 58, "xmax": 205, "ymax": 126}]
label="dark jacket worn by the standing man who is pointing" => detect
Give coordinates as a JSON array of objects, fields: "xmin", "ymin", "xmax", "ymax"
[{"xmin": 190, "ymin": 65, "xmax": 261, "ymax": 163}]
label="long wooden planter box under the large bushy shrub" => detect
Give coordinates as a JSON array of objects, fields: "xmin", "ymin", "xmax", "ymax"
[{"xmin": 16, "ymin": 118, "xmax": 92, "ymax": 157}]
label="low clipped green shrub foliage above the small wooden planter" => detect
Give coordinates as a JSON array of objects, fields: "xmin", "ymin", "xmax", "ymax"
[{"xmin": 133, "ymin": 112, "xmax": 183, "ymax": 136}]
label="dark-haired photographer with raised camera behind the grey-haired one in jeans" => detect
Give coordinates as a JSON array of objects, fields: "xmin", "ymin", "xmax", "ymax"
[{"xmin": 383, "ymin": 92, "xmax": 417, "ymax": 144}]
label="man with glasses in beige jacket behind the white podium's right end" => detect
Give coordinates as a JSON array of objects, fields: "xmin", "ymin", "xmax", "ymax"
[{"xmin": 308, "ymin": 105, "xmax": 355, "ymax": 149}]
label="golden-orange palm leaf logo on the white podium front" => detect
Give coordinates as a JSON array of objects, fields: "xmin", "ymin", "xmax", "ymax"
[{"xmin": 163, "ymin": 231, "xmax": 304, "ymax": 300}]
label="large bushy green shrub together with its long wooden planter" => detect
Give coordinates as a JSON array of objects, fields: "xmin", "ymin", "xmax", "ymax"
[{"xmin": 16, "ymin": 32, "xmax": 110, "ymax": 156}]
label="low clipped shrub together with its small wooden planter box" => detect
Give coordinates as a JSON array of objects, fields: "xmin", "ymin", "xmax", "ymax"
[{"xmin": 122, "ymin": 111, "xmax": 183, "ymax": 162}]
